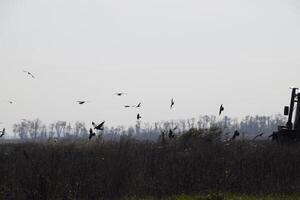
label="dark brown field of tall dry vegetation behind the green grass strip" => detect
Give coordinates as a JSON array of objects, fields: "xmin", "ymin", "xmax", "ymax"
[{"xmin": 0, "ymin": 130, "xmax": 300, "ymax": 199}]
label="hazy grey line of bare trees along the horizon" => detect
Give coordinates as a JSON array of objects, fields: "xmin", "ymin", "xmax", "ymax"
[{"xmin": 13, "ymin": 115, "xmax": 286, "ymax": 141}]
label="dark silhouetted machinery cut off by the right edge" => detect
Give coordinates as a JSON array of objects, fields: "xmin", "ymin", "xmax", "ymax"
[{"xmin": 272, "ymin": 88, "xmax": 300, "ymax": 144}]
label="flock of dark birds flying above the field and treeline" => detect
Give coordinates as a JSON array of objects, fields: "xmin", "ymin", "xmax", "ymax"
[{"xmin": 0, "ymin": 70, "xmax": 263, "ymax": 140}]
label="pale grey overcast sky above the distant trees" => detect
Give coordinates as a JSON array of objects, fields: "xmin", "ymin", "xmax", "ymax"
[{"xmin": 0, "ymin": 0, "xmax": 300, "ymax": 135}]
